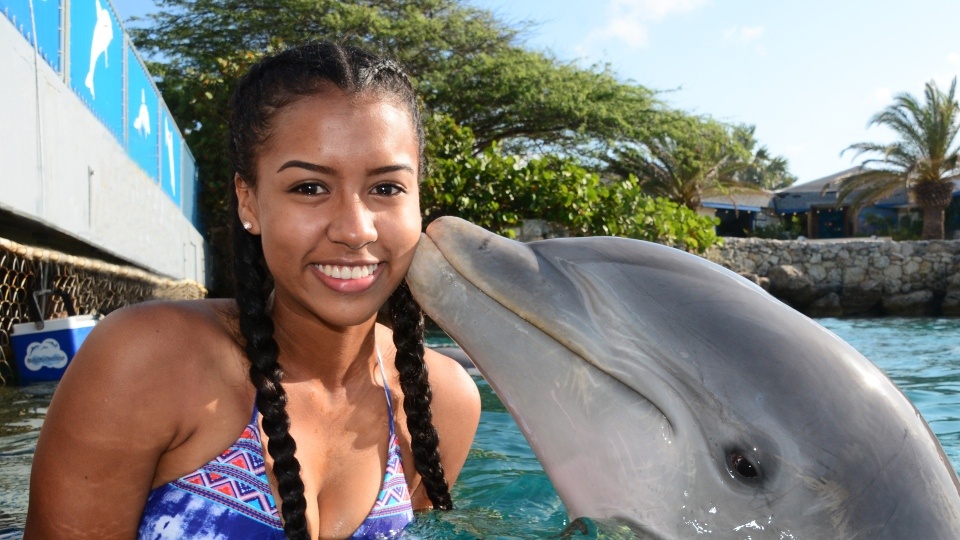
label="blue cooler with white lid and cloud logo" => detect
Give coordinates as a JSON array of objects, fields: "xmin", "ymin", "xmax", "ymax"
[{"xmin": 10, "ymin": 315, "xmax": 97, "ymax": 384}]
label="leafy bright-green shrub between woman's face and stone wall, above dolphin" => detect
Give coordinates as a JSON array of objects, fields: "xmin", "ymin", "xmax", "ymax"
[{"xmin": 421, "ymin": 115, "xmax": 720, "ymax": 253}]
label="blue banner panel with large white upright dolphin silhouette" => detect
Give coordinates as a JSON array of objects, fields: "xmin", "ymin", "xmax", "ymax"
[{"xmin": 69, "ymin": 0, "xmax": 124, "ymax": 141}]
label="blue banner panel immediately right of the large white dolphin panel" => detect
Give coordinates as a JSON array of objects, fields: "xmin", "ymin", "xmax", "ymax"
[{"xmin": 127, "ymin": 47, "xmax": 160, "ymax": 182}]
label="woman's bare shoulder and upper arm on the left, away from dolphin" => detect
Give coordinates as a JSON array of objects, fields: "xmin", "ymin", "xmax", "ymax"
[{"xmin": 29, "ymin": 301, "xmax": 252, "ymax": 536}]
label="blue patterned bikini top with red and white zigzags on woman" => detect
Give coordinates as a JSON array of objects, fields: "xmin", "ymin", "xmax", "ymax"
[{"xmin": 138, "ymin": 351, "xmax": 413, "ymax": 540}]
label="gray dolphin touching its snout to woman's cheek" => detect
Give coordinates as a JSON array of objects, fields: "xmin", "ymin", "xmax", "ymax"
[{"xmin": 407, "ymin": 218, "xmax": 960, "ymax": 539}]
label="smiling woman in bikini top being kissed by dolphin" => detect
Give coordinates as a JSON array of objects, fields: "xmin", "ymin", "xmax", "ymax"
[{"xmin": 25, "ymin": 40, "xmax": 480, "ymax": 539}]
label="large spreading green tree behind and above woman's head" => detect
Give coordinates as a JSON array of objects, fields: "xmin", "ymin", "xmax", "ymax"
[{"xmin": 131, "ymin": 0, "xmax": 659, "ymax": 232}]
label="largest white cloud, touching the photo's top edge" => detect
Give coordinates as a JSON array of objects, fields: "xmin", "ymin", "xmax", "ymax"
[{"xmin": 579, "ymin": 0, "xmax": 710, "ymax": 50}]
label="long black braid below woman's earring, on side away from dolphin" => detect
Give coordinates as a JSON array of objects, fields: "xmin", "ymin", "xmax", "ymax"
[{"xmin": 233, "ymin": 215, "xmax": 309, "ymax": 540}]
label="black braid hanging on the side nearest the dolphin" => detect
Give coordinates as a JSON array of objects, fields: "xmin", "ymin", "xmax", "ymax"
[{"xmin": 390, "ymin": 281, "xmax": 453, "ymax": 510}]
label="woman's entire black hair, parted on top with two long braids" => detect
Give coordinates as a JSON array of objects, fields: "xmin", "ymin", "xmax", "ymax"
[{"xmin": 229, "ymin": 42, "xmax": 452, "ymax": 539}]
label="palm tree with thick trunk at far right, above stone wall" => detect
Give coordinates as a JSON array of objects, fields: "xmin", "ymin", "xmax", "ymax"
[{"xmin": 837, "ymin": 78, "xmax": 960, "ymax": 240}]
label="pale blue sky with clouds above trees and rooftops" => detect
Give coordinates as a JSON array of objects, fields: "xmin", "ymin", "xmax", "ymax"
[{"xmin": 113, "ymin": 0, "xmax": 960, "ymax": 182}]
